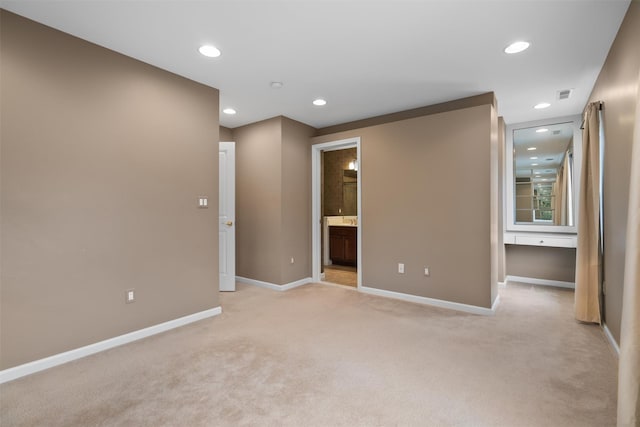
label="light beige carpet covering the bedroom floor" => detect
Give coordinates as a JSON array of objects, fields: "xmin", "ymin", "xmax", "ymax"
[{"xmin": 0, "ymin": 284, "xmax": 617, "ymax": 427}]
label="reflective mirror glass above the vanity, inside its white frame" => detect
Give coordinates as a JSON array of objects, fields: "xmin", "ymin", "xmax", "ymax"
[{"xmin": 513, "ymin": 122, "xmax": 575, "ymax": 226}]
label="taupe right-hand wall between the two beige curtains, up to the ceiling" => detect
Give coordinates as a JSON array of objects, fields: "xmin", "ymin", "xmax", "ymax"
[{"xmin": 590, "ymin": 0, "xmax": 640, "ymax": 341}]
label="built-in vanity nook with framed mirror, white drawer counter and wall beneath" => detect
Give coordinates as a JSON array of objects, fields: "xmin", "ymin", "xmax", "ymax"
[{"xmin": 503, "ymin": 116, "xmax": 582, "ymax": 287}]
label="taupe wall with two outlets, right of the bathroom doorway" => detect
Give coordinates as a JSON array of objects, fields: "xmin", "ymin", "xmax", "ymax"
[{"xmin": 312, "ymin": 101, "xmax": 498, "ymax": 307}]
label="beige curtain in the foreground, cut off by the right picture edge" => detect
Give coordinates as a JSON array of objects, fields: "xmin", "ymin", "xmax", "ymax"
[{"xmin": 618, "ymin": 70, "xmax": 640, "ymax": 426}]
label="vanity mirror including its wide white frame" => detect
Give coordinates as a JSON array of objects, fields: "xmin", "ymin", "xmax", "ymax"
[{"xmin": 506, "ymin": 116, "xmax": 581, "ymax": 233}]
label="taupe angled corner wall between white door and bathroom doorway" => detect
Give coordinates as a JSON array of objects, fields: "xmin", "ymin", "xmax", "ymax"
[{"xmin": 232, "ymin": 117, "xmax": 315, "ymax": 285}]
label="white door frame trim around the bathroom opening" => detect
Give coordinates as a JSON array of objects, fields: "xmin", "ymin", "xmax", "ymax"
[{"xmin": 311, "ymin": 136, "xmax": 363, "ymax": 290}]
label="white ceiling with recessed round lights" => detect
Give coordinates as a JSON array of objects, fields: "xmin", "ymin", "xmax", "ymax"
[{"xmin": 0, "ymin": 0, "xmax": 629, "ymax": 128}]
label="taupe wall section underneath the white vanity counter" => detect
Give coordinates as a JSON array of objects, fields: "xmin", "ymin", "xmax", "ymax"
[{"xmin": 506, "ymin": 245, "xmax": 576, "ymax": 282}]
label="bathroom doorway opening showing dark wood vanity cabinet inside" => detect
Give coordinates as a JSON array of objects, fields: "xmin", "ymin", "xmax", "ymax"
[{"xmin": 312, "ymin": 138, "xmax": 362, "ymax": 288}]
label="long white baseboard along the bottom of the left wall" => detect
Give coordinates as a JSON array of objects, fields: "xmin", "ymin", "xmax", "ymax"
[{"xmin": 0, "ymin": 307, "xmax": 222, "ymax": 384}]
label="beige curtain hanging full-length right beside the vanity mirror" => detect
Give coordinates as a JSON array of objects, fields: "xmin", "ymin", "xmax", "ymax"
[{"xmin": 575, "ymin": 102, "xmax": 601, "ymax": 323}]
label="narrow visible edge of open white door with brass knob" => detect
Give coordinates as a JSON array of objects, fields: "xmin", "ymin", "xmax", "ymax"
[{"xmin": 218, "ymin": 142, "xmax": 236, "ymax": 291}]
